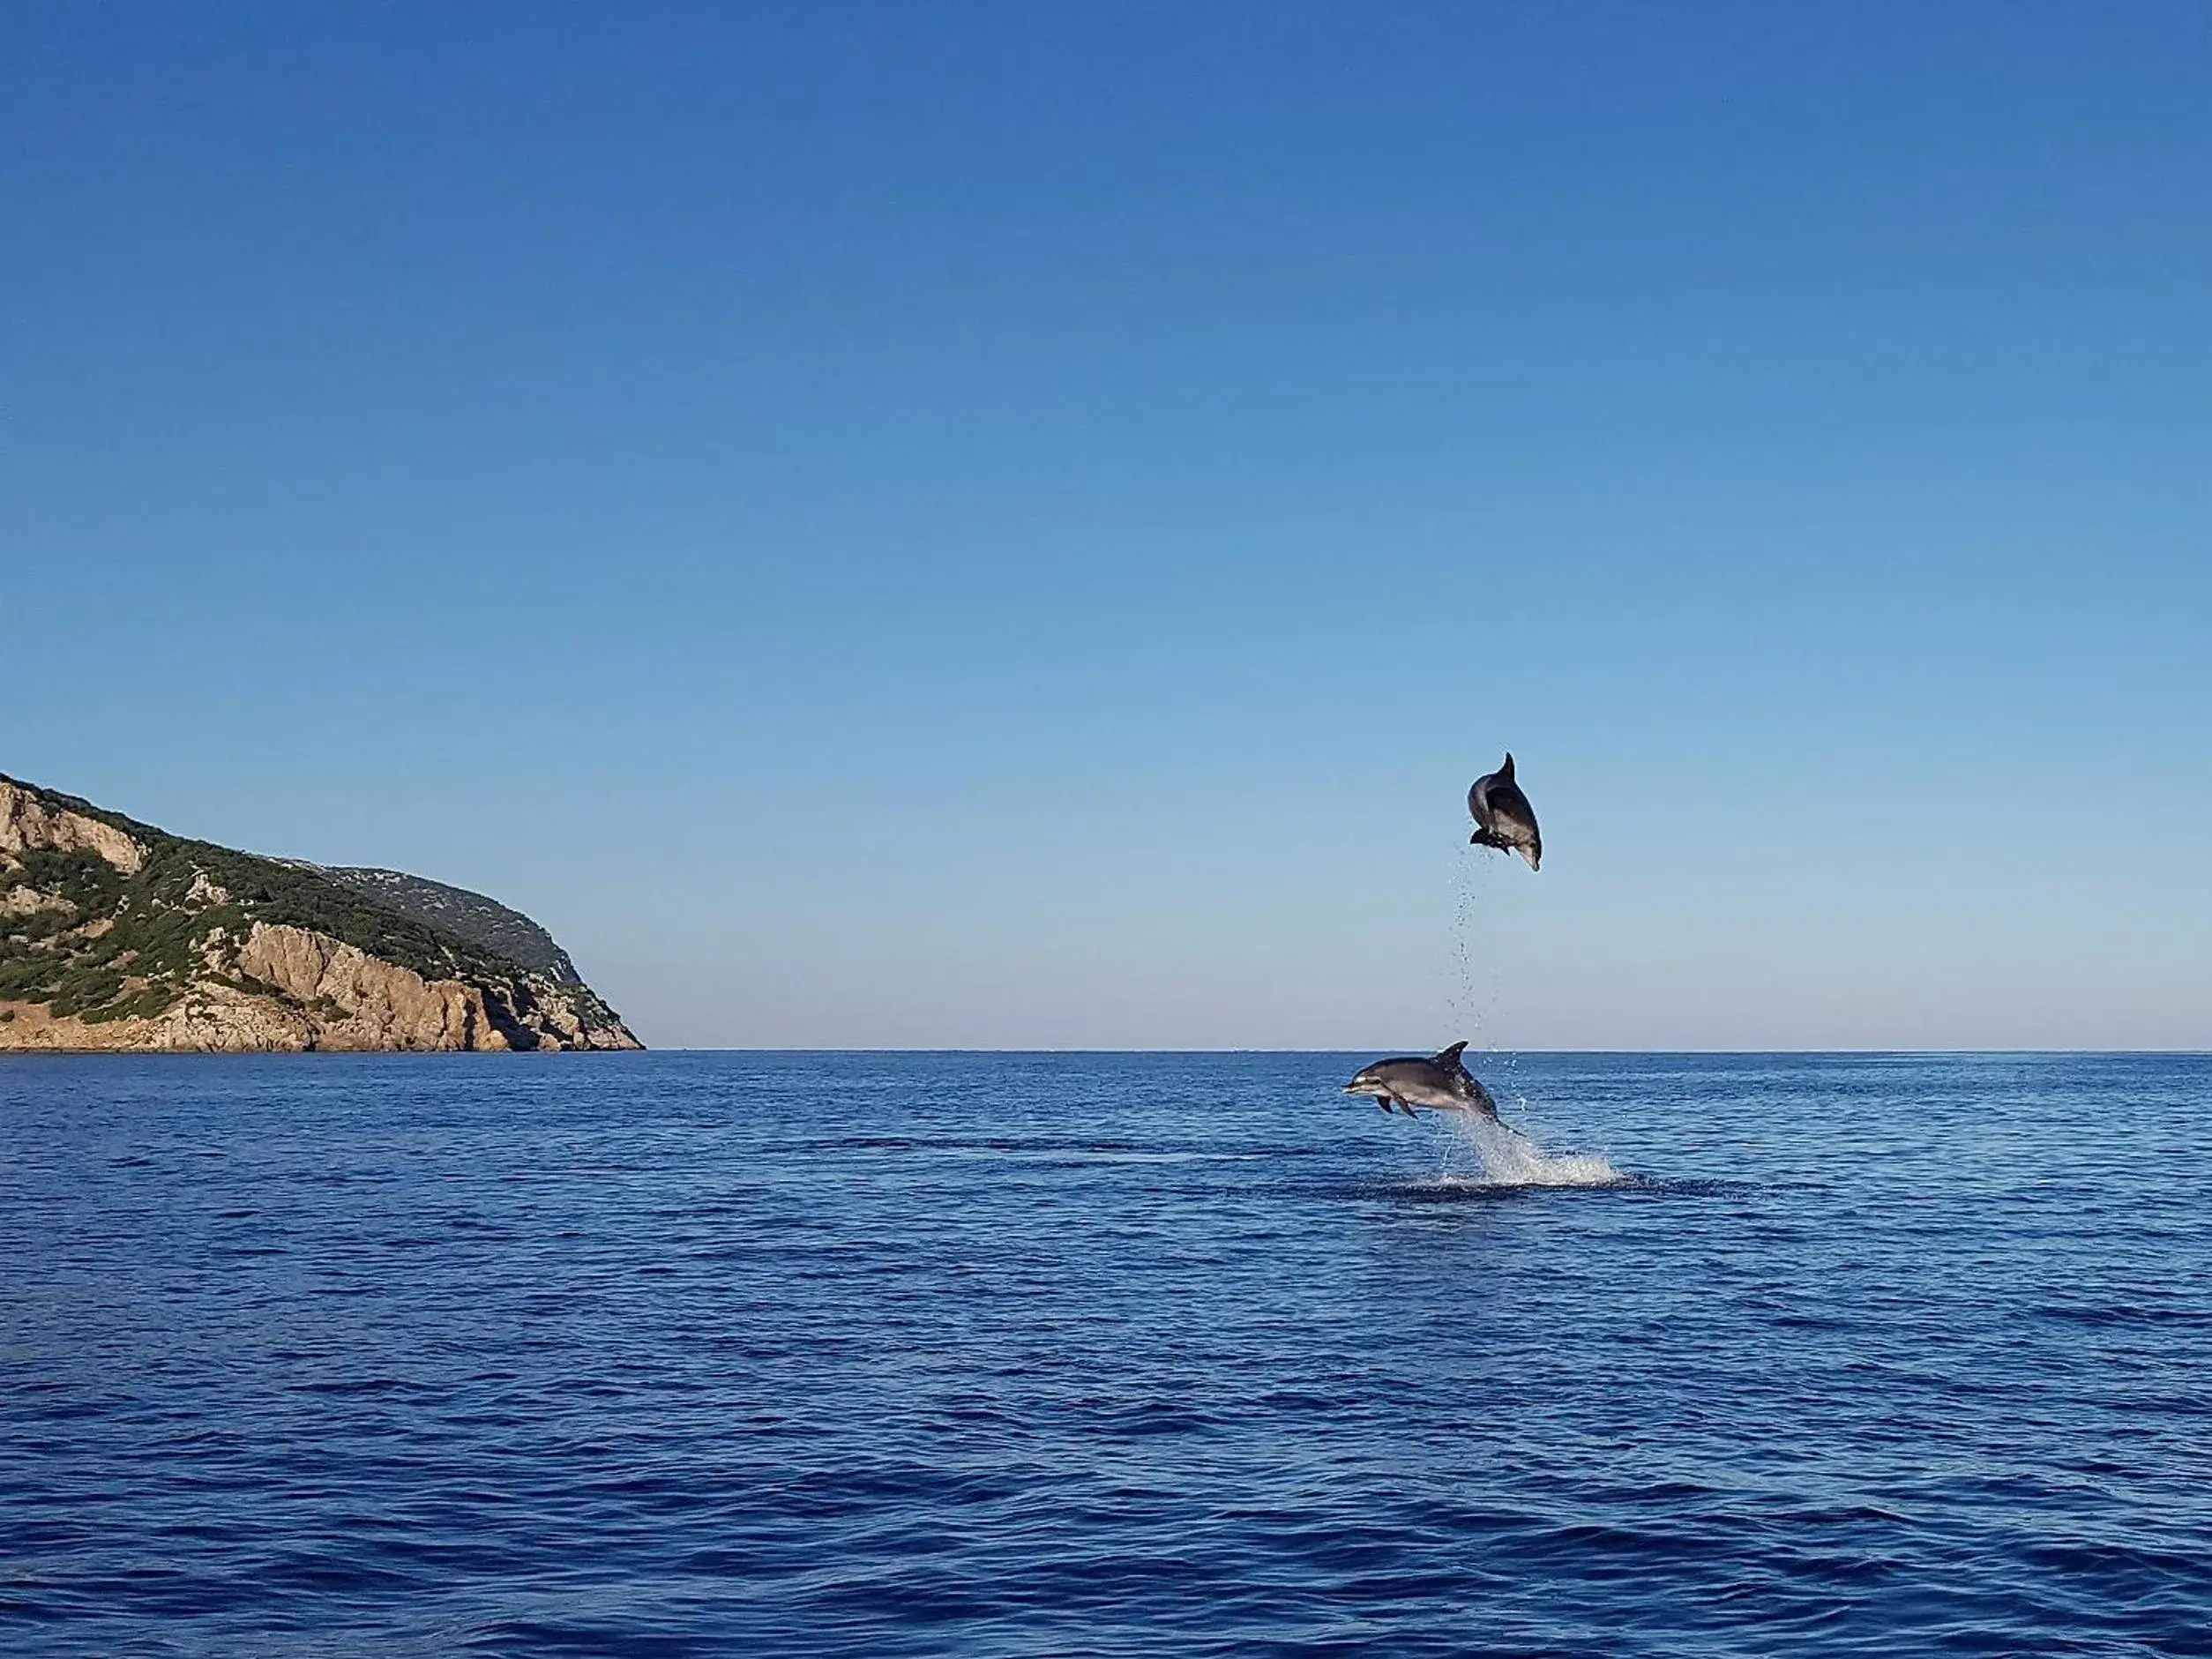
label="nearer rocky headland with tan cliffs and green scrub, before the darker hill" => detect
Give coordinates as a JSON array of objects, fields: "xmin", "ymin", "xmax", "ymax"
[{"xmin": 0, "ymin": 779, "xmax": 641, "ymax": 1053}]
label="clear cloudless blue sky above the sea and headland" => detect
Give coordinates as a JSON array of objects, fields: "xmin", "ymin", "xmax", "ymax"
[{"xmin": 0, "ymin": 0, "xmax": 2212, "ymax": 1049}]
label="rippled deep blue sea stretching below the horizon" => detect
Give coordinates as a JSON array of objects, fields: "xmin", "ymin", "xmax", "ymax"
[{"xmin": 0, "ymin": 1055, "xmax": 2212, "ymax": 1655}]
